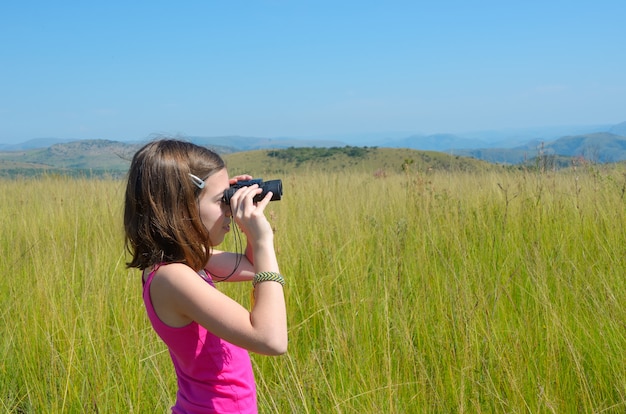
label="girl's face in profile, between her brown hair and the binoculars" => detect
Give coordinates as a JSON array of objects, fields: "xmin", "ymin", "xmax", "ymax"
[{"xmin": 198, "ymin": 168, "xmax": 231, "ymax": 246}]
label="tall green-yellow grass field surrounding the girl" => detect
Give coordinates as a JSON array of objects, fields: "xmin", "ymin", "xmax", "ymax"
[{"xmin": 0, "ymin": 163, "xmax": 626, "ymax": 413}]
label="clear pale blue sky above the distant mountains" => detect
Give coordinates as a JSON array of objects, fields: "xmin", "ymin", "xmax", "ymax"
[{"xmin": 0, "ymin": 0, "xmax": 626, "ymax": 143}]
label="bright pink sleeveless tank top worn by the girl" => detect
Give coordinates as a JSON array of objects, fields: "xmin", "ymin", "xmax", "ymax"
[{"xmin": 143, "ymin": 266, "xmax": 257, "ymax": 414}]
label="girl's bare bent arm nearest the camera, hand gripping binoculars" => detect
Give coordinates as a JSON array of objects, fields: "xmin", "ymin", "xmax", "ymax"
[{"xmin": 150, "ymin": 185, "xmax": 287, "ymax": 355}]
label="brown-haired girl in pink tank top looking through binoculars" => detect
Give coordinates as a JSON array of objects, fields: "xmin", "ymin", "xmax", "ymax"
[{"xmin": 124, "ymin": 140, "xmax": 287, "ymax": 413}]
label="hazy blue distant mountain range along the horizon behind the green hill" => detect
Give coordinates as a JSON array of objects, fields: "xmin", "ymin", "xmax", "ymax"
[{"xmin": 0, "ymin": 122, "xmax": 626, "ymax": 169}]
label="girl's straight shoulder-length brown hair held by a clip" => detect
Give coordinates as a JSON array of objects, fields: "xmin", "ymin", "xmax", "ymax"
[{"xmin": 124, "ymin": 139, "xmax": 225, "ymax": 271}]
